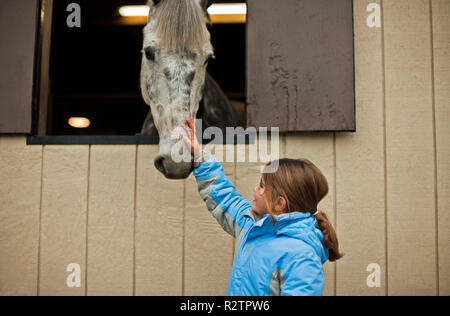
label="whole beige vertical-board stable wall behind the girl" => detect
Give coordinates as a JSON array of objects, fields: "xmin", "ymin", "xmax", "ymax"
[{"xmin": 0, "ymin": 0, "xmax": 450, "ymax": 295}]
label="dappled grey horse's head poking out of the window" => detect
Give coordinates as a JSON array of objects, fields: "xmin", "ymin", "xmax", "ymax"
[{"xmin": 141, "ymin": 0, "xmax": 213, "ymax": 179}]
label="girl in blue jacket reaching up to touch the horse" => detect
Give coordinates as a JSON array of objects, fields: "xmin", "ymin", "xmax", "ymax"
[{"xmin": 182, "ymin": 119, "xmax": 342, "ymax": 296}]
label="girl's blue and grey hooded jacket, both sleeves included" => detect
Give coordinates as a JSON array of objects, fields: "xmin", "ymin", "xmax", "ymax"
[{"xmin": 194, "ymin": 151, "xmax": 328, "ymax": 296}]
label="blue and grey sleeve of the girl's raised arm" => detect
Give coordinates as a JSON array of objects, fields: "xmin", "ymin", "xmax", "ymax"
[{"xmin": 194, "ymin": 150, "xmax": 253, "ymax": 237}]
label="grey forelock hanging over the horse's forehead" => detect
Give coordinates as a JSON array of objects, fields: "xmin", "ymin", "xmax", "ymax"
[{"xmin": 150, "ymin": 0, "xmax": 209, "ymax": 53}]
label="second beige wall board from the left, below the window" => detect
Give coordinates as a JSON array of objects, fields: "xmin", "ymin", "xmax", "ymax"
[{"xmin": 39, "ymin": 146, "xmax": 89, "ymax": 296}]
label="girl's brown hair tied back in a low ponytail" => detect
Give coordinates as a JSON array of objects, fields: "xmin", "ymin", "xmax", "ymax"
[{"xmin": 262, "ymin": 158, "xmax": 343, "ymax": 261}]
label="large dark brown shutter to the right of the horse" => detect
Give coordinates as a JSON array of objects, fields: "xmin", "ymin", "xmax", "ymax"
[{"xmin": 247, "ymin": 0, "xmax": 355, "ymax": 132}]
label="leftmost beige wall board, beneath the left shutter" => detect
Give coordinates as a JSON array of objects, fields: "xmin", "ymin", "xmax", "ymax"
[{"xmin": 0, "ymin": 136, "xmax": 42, "ymax": 296}]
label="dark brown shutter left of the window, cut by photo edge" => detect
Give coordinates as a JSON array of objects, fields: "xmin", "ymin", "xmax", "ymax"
[{"xmin": 0, "ymin": 0, "xmax": 38, "ymax": 133}]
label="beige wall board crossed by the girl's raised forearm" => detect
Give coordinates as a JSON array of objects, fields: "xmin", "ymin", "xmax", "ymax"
[{"xmin": 184, "ymin": 145, "xmax": 235, "ymax": 296}]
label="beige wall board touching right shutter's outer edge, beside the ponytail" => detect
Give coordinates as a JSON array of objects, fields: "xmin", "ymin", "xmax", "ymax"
[{"xmin": 336, "ymin": 0, "xmax": 386, "ymax": 295}]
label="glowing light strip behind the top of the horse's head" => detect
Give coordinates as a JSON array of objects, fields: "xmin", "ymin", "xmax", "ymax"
[{"xmin": 119, "ymin": 3, "xmax": 247, "ymax": 17}]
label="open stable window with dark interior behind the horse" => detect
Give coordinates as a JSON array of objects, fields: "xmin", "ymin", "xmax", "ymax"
[{"xmin": 28, "ymin": 0, "xmax": 250, "ymax": 144}]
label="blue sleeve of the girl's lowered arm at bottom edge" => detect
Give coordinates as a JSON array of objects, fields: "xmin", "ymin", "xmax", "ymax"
[{"xmin": 281, "ymin": 249, "xmax": 324, "ymax": 296}]
